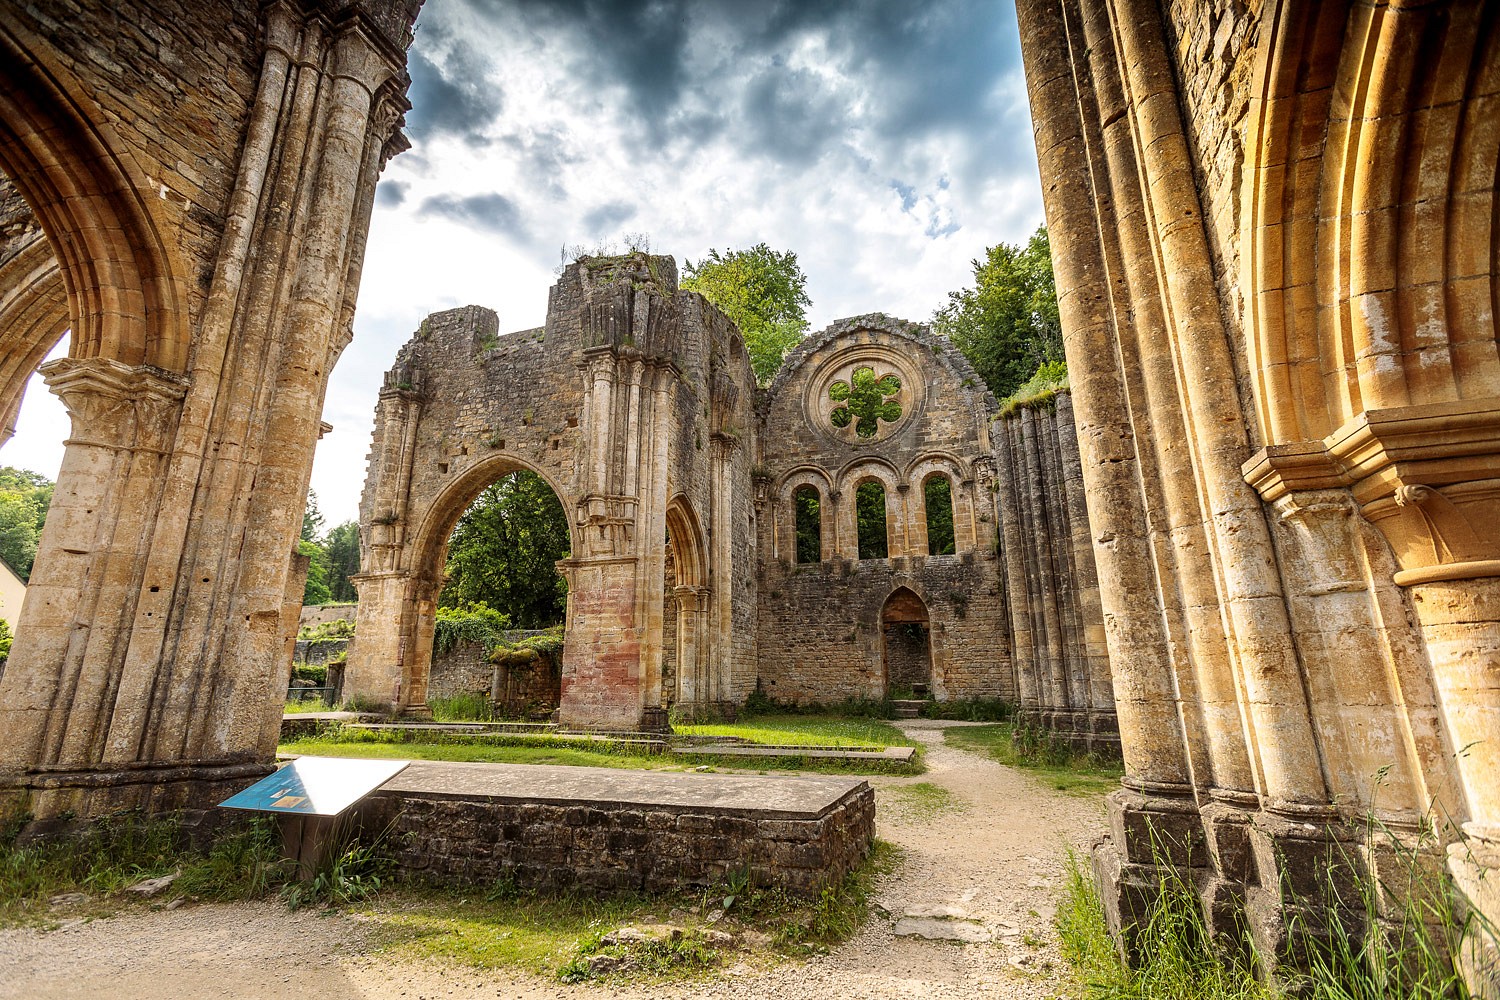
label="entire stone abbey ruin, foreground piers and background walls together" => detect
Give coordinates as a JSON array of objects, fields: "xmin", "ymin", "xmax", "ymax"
[{"xmin": 0, "ymin": 0, "xmax": 1500, "ymax": 991}]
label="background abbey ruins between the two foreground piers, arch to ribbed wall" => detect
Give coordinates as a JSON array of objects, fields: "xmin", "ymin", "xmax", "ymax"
[{"xmin": 345, "ymin": 274, "xmax": 1115, "ymax": 734}]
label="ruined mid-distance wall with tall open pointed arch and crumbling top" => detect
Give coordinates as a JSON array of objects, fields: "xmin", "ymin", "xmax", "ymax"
[{"xmin": 348, "ymin": 253, "xmax": 756, "ymax": 729}]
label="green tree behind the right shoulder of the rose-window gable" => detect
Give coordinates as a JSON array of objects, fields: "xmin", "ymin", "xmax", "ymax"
[{"xmin": 932, "ymin": 226, "xmax": 1064, "ymax": 399}]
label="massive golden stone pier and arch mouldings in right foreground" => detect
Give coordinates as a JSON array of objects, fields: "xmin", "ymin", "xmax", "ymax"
[{"xmin": 1020, "ymin": 0, "xmax": 1500, "ymax": 990}]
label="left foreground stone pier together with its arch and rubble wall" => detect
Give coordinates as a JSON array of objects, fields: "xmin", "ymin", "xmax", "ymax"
[{"xmin": 0, "ymin": 0, "xmax": 419, "ymax": 820}]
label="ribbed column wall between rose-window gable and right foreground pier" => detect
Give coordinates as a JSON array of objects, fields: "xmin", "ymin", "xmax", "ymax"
[{"xmin": 992, "ymin": 391, "xmax": 1119, "ymax": 756}]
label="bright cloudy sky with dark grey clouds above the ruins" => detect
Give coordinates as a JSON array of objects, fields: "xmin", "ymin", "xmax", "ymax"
[{"xmin": 0, "ymin": 0, "xmax": 1043, "ymax": 526}]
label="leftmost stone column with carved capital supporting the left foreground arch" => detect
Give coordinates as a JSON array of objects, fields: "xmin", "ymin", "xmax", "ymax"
[{"xmin": 0, "ymin": 358, "xmax": 186, "ymax": 769}]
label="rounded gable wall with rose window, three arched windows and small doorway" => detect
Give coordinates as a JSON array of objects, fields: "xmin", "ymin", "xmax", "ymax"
[{"xmin": 756, "ymin": 315, "xmax": 1016, "ymax": 703}]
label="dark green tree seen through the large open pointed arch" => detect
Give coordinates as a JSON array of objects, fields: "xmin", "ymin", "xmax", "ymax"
[{"xmin": 438, "ymin": 471, "xmax": 572, "ymax": 628}]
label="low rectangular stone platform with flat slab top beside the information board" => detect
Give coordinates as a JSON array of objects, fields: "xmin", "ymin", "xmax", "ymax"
[{"xmin": 360, "ymin": 760, "xmax": 875, "ymax": 894}]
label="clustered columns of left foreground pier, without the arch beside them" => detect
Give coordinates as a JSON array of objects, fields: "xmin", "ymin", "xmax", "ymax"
[{"xmin": 0, "ymin": 0, "xmax": 417, "ymax": 820}]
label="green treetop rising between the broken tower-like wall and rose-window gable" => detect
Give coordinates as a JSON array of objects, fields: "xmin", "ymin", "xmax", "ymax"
[{"xmin": 683, "ymin": 243, "xmax": 812, "ymax": 385}]
